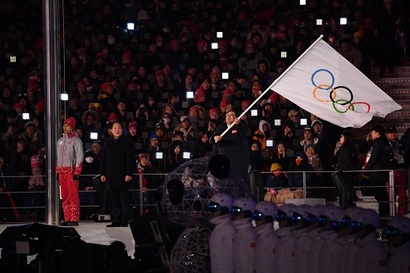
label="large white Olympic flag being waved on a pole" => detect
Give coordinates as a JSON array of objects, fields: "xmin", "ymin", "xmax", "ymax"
[{"xmin": 269, "ymin": 37, "xmax": 402, "ymax": 128}]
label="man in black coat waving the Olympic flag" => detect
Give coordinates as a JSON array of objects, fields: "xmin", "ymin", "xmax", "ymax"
[{"xmin": 209, "ymin": 110, "xmax": 250, "ymax": 183}]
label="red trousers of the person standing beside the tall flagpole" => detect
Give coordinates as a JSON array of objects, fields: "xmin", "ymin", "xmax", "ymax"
[{"xmin": 58, "ymin": 173, "xmax": 80, "ymax": 222}]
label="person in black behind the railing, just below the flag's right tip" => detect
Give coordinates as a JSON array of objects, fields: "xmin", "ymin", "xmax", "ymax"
[{"xmin": 363, "ymin": 125, "xmax": 392, "ymax": 216}]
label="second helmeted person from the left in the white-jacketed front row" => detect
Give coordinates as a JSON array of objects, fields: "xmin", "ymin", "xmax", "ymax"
[{"xmin": 231, "ymin": 197, "xmax": 258, "ymax": 273}]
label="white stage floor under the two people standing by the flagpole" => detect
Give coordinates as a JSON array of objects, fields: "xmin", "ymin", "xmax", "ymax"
[{"xmin": 0, "ymin": 220, "xmax": 134, "ymax": 258}]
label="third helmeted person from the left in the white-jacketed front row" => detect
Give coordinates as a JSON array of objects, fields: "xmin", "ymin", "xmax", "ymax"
[{"xmin": 253, "ymin": 201, "xmax": 279, "ymax": 273}]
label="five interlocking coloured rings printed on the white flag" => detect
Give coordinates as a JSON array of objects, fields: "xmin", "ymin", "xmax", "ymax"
[{"xmin": 310, "ymin": 68, "xmax": 371, "ymax": 114}]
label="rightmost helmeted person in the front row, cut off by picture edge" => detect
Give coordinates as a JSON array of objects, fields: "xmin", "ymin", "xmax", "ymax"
[{"xmin": 385, "ymin": 214, "xmax": 410, "ymax": 273}]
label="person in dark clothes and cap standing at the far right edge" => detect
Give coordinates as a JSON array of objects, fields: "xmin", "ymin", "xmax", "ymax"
[{"xmin": 386, "ymin": 125, "xmax": 409, "ymax": 215}]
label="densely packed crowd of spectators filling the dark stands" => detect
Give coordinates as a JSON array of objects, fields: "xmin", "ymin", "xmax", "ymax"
[{"xmin": 0, "ymin": 0, "xmax": 410, "ymax": 219}]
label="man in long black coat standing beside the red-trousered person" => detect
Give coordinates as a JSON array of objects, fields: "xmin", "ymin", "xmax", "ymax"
[{"xmin": 101, "ymin": 121, "xmax": 135, "ymax": 227}]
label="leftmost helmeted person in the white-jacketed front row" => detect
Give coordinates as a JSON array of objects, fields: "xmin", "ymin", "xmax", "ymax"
[{"xmin": 208, "ymin": 193, "xmax": 236, "ymax": 273}]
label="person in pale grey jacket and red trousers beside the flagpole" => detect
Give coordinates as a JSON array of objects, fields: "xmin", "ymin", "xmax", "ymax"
[{"xmin": 56, "ymin": 117, "xmax": 84, "ymax": 226}]
